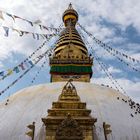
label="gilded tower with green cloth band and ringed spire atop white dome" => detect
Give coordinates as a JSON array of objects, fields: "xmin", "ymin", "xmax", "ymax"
[{"xmin": 50, "ymin": 4, "xmax": 93, "ymax": 82}]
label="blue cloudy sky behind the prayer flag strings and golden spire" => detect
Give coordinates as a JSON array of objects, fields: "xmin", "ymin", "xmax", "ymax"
[{"xmin": 0, "ymin": 0, "xmax": 140, "ymax": 102}]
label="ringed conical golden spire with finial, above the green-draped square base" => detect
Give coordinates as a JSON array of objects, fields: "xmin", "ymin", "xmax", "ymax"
[{"xmin": 55, "ymin": 3, "xmax": 88, "ymax": 57}]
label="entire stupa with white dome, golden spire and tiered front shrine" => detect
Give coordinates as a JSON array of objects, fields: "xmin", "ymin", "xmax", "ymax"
[{"xmin": 0, "ymin": 4, "xmax": 140, "ymax": 140}]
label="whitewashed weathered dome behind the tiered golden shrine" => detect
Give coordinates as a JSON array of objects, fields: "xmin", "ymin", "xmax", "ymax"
[{"xmin": 0, "ymin": 82, "xmax": 140, "ymax": 140}]
